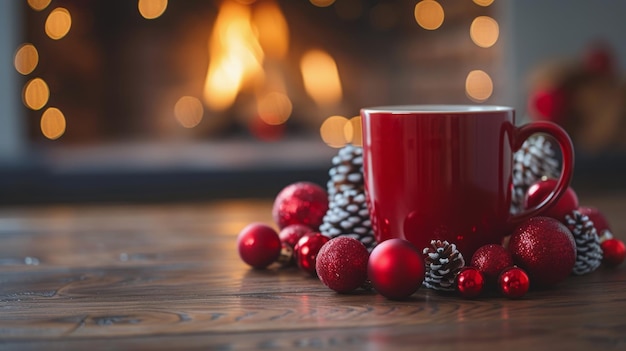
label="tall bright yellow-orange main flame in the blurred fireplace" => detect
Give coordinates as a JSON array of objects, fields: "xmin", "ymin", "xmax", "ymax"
[{"xmin": 203, "ymin": 1, "xmax": 263, "ymax": 110}]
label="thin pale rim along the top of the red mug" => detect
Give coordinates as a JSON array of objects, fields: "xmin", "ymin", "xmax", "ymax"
[{"xmin": 361, "ymin": 104, "xmax": 514, "ymax": 114}]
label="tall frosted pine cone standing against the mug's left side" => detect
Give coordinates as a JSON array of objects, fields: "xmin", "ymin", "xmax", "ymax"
[{"xmin": 320, "ymin": 145, "xmax": 376, "ymax": 250}]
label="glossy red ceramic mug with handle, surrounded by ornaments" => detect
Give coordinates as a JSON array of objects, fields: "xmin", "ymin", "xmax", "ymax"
[{"xmin": 361, "ymin": 105, "xmax": 574, "ymax": 260}]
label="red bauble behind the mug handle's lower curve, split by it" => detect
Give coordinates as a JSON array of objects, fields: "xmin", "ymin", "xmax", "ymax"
[{"xmin": 524, "ymin": 179, "xmax": 578, "ymax": 222}]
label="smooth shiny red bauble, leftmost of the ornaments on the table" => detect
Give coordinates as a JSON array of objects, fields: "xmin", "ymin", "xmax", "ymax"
[{"xmin": 237, "ymin": 223, "xmax": 281, "ymax": 268}]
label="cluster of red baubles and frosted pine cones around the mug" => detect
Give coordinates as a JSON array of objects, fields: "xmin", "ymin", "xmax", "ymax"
[{"xmin": 237, "ymin": 144, "xmax": 626, "ymax": 300}]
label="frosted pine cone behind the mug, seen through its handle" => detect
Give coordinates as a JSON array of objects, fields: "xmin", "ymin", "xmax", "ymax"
[{"xmin": 511, "ymin": 135, "xmax": 560, "ymax": 213}]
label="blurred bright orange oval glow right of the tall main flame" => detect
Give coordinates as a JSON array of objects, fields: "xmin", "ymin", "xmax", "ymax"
[{"xmin": 300, "ymin": 50, "xmax": 342, "ymax": 105}]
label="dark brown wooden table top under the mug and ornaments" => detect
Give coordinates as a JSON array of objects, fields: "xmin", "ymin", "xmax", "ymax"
[{"xmin": 0, "ymin": 192, "xmax": 626, "ymax": 350}]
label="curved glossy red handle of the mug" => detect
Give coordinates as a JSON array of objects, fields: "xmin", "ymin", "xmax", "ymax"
[{"xmin": 509, "ymin": 121, "xmax": 574, "ymax": 224}]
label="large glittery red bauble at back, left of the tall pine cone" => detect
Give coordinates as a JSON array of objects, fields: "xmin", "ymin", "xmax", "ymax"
[{"xmin": 272, "ymin": 182, "xmax": 328, "ymax": 230}]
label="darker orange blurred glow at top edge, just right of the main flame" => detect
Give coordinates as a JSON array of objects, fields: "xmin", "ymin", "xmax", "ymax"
[{"xmin": 252, "ymin": 1, "xmax": 289, "ymax": 58}]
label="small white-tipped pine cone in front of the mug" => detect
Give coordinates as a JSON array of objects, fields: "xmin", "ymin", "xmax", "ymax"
[{"xmin": 422, "ymin": 240, "xmax": 465, "ymax": 291}]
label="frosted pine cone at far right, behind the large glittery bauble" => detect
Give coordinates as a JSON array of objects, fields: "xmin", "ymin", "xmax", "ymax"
[{"xmin": 565, "ymin": 210, "xmax": 602, "ymax": 275}]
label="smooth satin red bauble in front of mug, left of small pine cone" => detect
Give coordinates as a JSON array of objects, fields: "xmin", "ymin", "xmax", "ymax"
[{"xmin": 367, "ymin": 239, "xmax": 425, "ymax": 300}]
